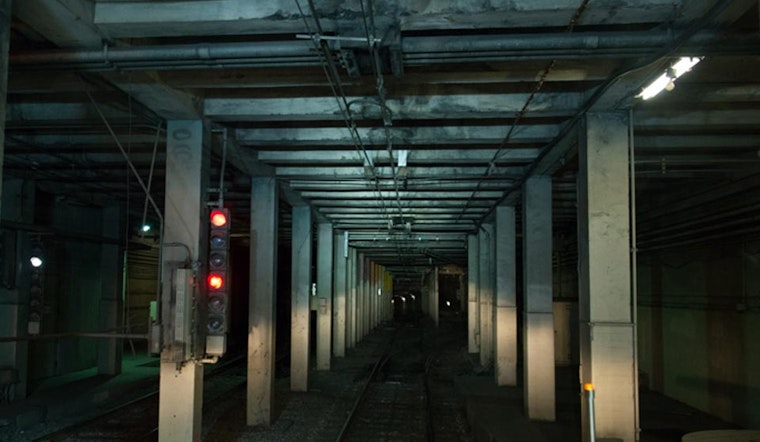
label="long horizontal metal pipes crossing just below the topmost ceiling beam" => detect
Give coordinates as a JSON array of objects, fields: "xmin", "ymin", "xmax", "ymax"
[{"xmin": 9, "ymin": 30, "xmax": 744, "ymax": 70}]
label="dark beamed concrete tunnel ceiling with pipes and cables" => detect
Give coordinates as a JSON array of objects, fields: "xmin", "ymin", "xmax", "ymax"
[{"xmin": 4, "ymin": 0, "xmax": 760, "ymax": 272}]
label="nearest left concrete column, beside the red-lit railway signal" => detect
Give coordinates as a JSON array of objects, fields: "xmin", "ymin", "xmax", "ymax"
[{"xmin": 158, "ymin": 120, "xmax": 209, "ymax": 442}]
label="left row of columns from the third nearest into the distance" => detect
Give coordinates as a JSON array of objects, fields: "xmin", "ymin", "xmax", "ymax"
[{"xmin": 290, "ymin": 218, "xmax": 392, "ymax": 391}]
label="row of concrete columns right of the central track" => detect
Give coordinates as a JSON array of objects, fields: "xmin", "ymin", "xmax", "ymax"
[{"xmin": 468, "ymin": 113, "xmax": 638, "ymax": 441}]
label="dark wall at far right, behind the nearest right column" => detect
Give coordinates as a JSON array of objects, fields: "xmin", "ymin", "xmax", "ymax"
[{"xmin": 637, "ymin": 242, "xmax": 760, "ymax": 428}]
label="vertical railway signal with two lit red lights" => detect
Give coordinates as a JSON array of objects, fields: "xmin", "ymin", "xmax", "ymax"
[{"xmin": 206, "ymin": 208, "xmax": 230, "ymax": 356}]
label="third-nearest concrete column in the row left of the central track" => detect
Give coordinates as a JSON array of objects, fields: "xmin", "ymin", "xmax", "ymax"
[{"xmin": 290, "ymin": 206, "xmax": 312, "ymax": 391}]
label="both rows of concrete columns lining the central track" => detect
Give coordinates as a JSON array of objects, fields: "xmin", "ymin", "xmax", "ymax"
[{"xmin": 159, "ymin": 113, "xmax": 638, "ymax": 441}]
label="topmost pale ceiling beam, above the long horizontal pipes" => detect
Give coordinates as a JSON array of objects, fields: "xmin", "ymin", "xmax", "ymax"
[{"xmin": 95, "ymin": 0, "xmax": 680, "ymax": 37}]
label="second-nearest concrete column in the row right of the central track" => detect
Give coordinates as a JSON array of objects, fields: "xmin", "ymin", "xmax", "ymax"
[{"xmin": 522, "ymin": 177, "xmax": 556, "ymax": 421}]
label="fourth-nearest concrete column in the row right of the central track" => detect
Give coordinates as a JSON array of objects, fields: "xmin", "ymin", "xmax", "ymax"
[{"xmin": 478, "ymin": 224, "xmax": 496, "ymax": 367}]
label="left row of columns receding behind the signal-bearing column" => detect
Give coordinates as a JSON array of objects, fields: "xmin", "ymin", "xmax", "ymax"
[{"xmin": 247, "ymin": 200, "xmax": 392, "ymax": 425}]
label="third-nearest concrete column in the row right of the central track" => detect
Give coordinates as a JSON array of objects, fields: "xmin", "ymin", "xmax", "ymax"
[{"xmin": 494, "ymin": 206, "xmax": 517, "ymax": 386}]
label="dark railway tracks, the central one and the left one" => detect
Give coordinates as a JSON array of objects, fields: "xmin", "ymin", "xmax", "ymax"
[{"xmin": 37, "ymin": 314, "xmax": 472, "ymax": 442}]
